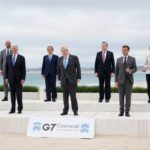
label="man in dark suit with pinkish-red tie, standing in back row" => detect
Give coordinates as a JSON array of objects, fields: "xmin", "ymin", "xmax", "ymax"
[{"xmin": 95, "ymin": 42, "xmax": 115, "ymax": 102}]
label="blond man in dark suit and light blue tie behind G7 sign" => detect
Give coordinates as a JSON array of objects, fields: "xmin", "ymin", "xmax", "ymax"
[{"xmin": 58, "ymin": 47, "xmax": 81, "ymax": 116}]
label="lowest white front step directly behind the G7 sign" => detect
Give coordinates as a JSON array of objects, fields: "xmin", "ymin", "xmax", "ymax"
[{"xmin": 0, "ymin": 111, "xmax": 150, "ymax": 136}]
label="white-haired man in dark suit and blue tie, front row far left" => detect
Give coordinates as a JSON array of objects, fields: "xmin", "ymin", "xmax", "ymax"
[{"xmin": 5, "ymin": 45, "xmax": 26, "ymax": 114}]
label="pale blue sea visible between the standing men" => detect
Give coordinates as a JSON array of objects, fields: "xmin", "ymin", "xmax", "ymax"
[{"xmin": 0, "ymin": 68, "xmax": 146, "ymax": 88}]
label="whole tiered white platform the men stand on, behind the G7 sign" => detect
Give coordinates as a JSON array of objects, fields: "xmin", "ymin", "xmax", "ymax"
[{"xmin": 0, "ymin": 94, "xmax": 150, "ymax": 136}]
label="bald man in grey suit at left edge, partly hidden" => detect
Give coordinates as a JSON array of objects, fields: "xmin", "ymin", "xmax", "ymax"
[{"xmin": 0, "ymin": 41, "xmax": 12, "ymax": 101}]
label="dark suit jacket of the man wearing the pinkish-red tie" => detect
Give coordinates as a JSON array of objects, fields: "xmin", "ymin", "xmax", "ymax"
[{"xmin": 95, "ymin": 51, "xmax": 115, "ymax": 75}]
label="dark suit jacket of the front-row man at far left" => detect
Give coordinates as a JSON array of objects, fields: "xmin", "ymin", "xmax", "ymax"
[{"xmin": 5, "ymin": 54, "xmax": 26, "ymax": 83}]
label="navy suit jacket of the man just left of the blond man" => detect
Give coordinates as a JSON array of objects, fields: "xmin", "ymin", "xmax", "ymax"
[{"xmin": 41, "ymin": 55, "xmax": 58, "ymax": 77}]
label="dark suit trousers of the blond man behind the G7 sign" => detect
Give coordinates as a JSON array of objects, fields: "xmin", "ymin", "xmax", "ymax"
[{"xmin": 62, "ymin": 79, "xmax": 78, "ymax": 113}]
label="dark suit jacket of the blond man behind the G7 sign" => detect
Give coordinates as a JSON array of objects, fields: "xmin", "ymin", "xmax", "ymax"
[{"xmin": 58, "ymin": 55, "xmax": 81, "ymax": 85}]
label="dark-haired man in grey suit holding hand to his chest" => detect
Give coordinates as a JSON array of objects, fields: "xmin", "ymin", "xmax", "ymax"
[{"xmin": 115, "ymin": 45, "xmax": 137, "ymax": 117}]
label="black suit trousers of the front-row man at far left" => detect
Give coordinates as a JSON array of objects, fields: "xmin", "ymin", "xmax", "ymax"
[{"xmin": 9, "ymin": 81, "xmax": 23, "ymax": 111}]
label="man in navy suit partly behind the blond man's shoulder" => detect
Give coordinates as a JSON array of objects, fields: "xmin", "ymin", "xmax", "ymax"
[{"xmin": 41, "ymin": 46, "xmax": 58, "ymax": 102}]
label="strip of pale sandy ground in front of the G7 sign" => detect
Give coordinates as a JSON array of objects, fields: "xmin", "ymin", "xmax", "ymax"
[{"xmin": 0, "ymin": 134, "xmax": 150, "ymax": 150}]
